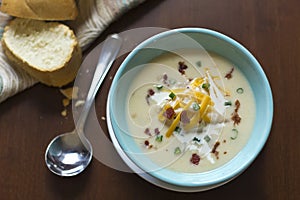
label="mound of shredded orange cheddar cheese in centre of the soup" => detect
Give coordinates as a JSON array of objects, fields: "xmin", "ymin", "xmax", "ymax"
[{"xmin": 158, "ymin": 72, "xmax": 227, "ymax": 137}]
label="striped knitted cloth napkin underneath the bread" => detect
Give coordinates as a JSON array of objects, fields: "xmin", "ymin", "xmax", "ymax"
[{"xmin": 0, "ymin": 0, "xmax": 144, "ymax": 103}]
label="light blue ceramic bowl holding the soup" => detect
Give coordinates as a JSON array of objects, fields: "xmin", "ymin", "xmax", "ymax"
[{"xmin": 108, "ymin": 28, "xmax": 273, "ymax": 187}]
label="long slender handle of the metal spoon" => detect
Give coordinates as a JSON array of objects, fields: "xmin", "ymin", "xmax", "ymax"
[{"xmin": 76, "ymin": 34, "xmax": 122, "ymax": 131}]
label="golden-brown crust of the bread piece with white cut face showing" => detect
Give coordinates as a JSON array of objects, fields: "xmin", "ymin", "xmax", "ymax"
[{"xmin": 1, "ymin": 19, "xmax": 82, "ymax": 87}]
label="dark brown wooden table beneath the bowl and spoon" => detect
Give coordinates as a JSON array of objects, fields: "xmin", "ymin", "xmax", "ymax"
[{"xmin": 0, "ymin": 0, "xmax": 300, "ymax": 200}]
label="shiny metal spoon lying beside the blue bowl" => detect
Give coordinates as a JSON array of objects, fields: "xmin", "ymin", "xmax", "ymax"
[{"xmin": 45, "ymin": 34, "xmax": 122, "ymax": 176}]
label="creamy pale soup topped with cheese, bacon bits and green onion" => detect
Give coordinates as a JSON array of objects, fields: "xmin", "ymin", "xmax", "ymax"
[{"xmin": 123, "ymin": 49, "xmax": 256, "ymax": 173}]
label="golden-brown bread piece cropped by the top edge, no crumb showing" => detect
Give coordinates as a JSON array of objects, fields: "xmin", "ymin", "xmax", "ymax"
[{"xmin": 0, "ymin": 0, "xmax": 78, "ymax": 20}]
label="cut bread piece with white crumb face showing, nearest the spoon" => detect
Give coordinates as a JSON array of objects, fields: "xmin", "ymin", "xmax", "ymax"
[{"xmin": 2, "ymin": 18, "xmax": 82, "ymax": 86}]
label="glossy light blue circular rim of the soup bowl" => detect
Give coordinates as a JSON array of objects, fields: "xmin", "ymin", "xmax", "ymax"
[{"xmin": 108, "ymin": 27, "xmax": 273, "ymax": 187}]
